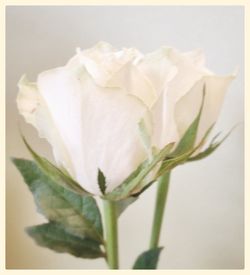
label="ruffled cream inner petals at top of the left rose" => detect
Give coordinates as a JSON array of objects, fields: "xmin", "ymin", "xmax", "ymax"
[{"xmin": 72, "ymin": 42, "xmax": 157, "ymax": 107}]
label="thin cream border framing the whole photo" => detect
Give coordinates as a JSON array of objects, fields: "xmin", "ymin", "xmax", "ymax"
[{"xmin": 0, "ymin": 0, "xmax": 250, "ymax": 275}]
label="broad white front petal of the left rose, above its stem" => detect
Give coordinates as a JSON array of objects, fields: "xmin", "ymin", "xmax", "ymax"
[{"xmin": 38, "ymin": 67, "xmax": 149, "ymax": 194}]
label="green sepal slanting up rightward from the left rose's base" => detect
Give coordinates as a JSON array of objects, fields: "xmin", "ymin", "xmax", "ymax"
[{"xmin": 105, "ymin": 143, "xmax": 174, "ymax": 201}]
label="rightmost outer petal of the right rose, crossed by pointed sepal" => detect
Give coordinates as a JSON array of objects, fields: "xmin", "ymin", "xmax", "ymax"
[{"xmin": 175, "ymin": 75, "xmax": 235, "ymax": 146}]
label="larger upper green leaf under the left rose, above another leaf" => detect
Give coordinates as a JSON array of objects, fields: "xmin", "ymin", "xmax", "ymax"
[{"xmin": 13, "ymin": 159, "xmax": 103, "ymax": 245}]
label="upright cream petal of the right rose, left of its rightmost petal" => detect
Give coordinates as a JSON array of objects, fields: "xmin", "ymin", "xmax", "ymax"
[{"xmin": 152, "ymin": 48, "xmax": 209, "ymax": 148}]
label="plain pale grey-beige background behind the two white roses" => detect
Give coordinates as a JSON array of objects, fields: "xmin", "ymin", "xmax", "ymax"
[{"xmin": 6, "ymin": 6, "xmax": 244, "ymax": 269}]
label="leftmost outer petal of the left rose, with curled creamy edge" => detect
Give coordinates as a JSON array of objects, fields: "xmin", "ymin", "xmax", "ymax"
[{"xmin": 17, "ymin": 76, "xmax": 74, "ymax": 174}]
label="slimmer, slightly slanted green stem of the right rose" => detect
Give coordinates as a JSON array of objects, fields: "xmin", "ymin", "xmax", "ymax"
[{"xmin": 150, "ymin": 172, "xmax": 170, "ymax": 249}]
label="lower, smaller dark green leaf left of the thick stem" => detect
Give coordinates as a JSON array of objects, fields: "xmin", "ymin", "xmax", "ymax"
[{"xmin": 26, "ymin": 222, "xmax": 105, "ymax": 259}]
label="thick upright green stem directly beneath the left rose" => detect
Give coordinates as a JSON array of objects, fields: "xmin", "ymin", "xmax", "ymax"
[{"xmin": 103, "ymin": 200, "xmax": 119, "ymax": 269}]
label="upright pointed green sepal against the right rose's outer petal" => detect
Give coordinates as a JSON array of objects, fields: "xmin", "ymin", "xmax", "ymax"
[{"xmin": 173, "ymin": 85, "xmax": 205, "ymax": 156}]
